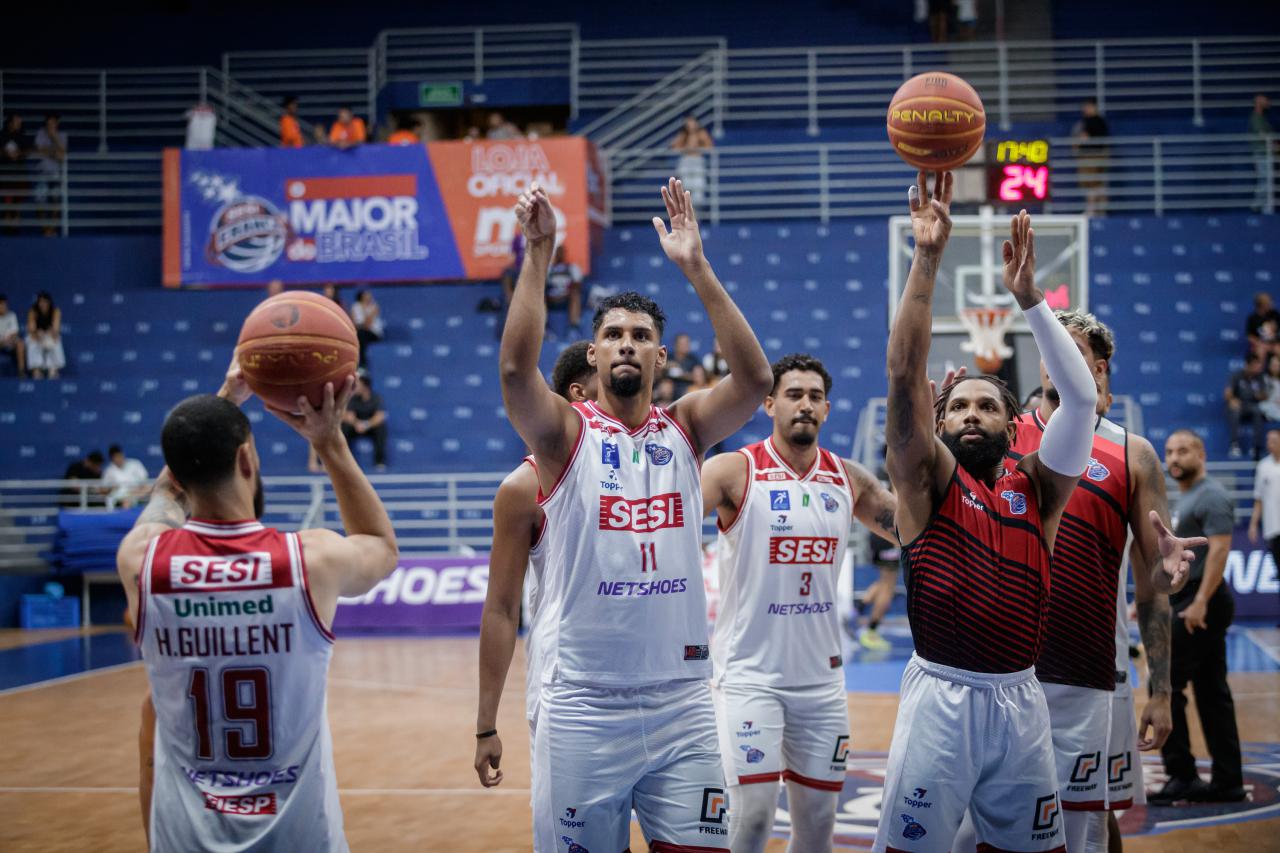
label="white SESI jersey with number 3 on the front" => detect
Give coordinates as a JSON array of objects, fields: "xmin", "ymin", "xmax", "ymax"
[{"xmin": 712, "ymin": 438, "xmax": 854, "ymax": 686}]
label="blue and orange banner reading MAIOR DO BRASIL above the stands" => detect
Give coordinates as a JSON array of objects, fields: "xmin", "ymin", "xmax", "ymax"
[{"xmin": 164, "ymin": 137, "xmax": 604, "ymax": 287}]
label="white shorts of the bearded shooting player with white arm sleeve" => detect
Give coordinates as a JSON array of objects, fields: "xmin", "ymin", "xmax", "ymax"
[{"xmin": 872, "ymin": 654, "xmax": 1065, "ymax": 853}]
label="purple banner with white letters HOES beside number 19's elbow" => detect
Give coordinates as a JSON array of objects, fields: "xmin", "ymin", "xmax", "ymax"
[{"xmin": 333, "ymin": 555, "xmax": 489, "ymax": 634}]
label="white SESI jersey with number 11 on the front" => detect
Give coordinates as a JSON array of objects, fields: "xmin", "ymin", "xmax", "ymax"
[{"xmin": 536, "ymin": 402, "xmax": 710, "ymax": 686}]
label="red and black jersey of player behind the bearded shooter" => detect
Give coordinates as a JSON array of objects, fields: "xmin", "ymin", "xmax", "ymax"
[{"xmin": 1009, "ymin": 411, "xmax": 1130, "ymax": 690}]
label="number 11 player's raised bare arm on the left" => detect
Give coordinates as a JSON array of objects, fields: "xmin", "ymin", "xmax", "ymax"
[{"xmin": 498, "ymin": 183, "xmax": 580, "ymax": 485}]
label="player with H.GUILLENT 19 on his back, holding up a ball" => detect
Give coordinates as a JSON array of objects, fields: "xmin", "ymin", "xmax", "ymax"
[{"xmin": 116, "ymin": 361, "xmax": 398, "ymax": 850}]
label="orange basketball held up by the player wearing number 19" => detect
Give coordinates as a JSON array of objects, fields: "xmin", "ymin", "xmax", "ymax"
[{"xmin": 237, "ymin": 291, "xmax": 360, "ymax": 412}]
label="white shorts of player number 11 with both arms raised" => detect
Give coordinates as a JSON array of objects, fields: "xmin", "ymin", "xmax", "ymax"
[{"xmin": 532, "ymin": 681, "xmax": 730, "ymax": 853}]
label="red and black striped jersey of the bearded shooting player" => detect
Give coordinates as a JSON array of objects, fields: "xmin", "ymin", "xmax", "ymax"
[{"xmin": 902, "ymin": 465, "xmax": 1050, "ymax": 672}]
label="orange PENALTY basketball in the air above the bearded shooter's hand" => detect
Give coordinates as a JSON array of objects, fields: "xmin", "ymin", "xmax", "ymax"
[{"xmin": 888, "ymin": 72, "xmax": 987, "ymax": 172}]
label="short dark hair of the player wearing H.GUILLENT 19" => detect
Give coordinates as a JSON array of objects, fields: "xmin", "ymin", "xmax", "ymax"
[{"xmin": 160, "ymin": 394, "xmax": 251, "ymax": 489}]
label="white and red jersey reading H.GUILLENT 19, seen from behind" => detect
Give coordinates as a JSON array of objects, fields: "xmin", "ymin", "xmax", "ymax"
[{"xmin": 137, "ymin": 520, "xmax": 347, "ymax": 852}]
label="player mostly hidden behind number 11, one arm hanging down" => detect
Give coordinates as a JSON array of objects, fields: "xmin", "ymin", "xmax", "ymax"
[{"xmin": 475, "ymin": 341, "xmax": 599, "ymax": 788}]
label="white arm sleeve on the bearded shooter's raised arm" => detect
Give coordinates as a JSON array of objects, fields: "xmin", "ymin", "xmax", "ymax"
[{"xmin": 1023, "ymin": 300, "xmax": 1098, "ymax": 476}]
